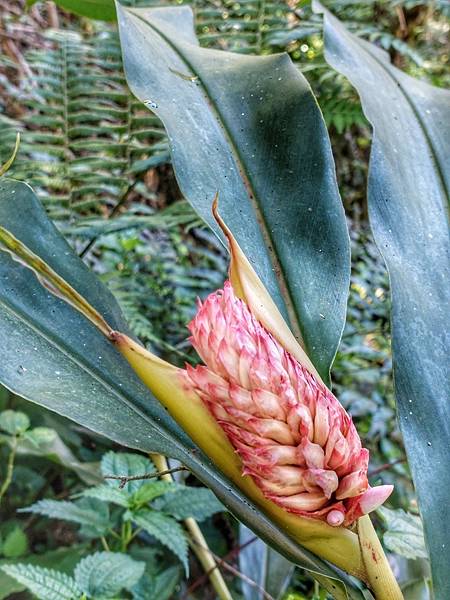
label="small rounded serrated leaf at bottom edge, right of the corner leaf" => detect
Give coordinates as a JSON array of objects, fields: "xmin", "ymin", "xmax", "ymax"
[{"xmin": 74, "ymin": 552, "xmax": 145, "ymax": 598}]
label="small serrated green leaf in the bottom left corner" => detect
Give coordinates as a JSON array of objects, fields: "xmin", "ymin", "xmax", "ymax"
[{"xmin": 0, "ymin": 563, "xmax": 81, "ymax": 600}]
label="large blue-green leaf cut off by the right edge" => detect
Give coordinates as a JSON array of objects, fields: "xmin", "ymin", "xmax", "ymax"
[{"xmin": 316, "ymin": 4, "xmax": 450, "ymax": 598}]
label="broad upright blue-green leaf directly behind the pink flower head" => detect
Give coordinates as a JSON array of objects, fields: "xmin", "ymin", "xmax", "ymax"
[{"xmin": 117, "ymin": 5, "xmax": 349, "ymax": 379}]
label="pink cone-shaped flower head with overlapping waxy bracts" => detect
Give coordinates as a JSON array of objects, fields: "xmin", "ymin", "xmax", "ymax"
[{"xmin": 184, "ymin": 281, "xmax": 392, "ymax": 526}]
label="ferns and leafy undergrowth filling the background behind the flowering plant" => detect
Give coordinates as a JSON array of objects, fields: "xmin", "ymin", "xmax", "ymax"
[{"xmin": 0, "ymin": 0, "xmax": 449, "ymax": 600}]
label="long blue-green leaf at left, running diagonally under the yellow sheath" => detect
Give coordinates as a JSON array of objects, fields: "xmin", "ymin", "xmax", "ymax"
[{"xmin": 0, "ymin": 179, "xmax": 364, "ymax": 600}]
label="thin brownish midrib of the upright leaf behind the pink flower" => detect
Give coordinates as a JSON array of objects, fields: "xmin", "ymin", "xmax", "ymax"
[{"xmin": 129, "ymin": 9, "xmax": 305, "ymax": 348}]
